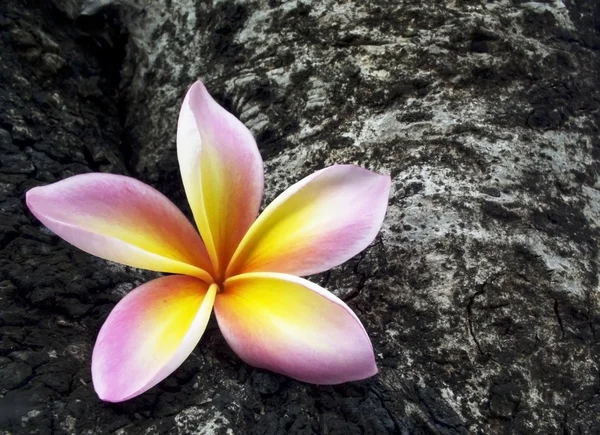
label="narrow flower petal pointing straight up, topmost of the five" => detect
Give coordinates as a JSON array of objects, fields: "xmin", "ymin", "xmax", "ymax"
[{"xmin": 177, "ymin": 81, "xmax": 264, "ymax": 278}]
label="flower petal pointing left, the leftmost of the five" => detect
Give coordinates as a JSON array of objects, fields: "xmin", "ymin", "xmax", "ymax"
[{"xmin": 27, "ymin": 174, "xmax": 212, "ymax": 282}]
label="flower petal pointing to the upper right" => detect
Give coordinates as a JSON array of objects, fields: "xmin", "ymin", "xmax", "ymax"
[{"xmin": 226, "ymin": 165, "xmax": 390, "ymax": 277}]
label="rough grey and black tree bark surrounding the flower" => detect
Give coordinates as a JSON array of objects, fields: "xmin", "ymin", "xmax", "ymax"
[{"xmin": 0, "ymin": 0, "xmax": 600, "ymax": 435}]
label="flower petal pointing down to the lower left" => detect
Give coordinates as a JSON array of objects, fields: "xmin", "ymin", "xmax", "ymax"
[{"xmin": 92, "ymin": 275, "xmax": 217, "ymax": 402}]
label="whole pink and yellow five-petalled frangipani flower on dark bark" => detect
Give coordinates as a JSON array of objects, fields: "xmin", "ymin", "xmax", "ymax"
[{"xmin": 27, "ymin": 82, "xmax": 390, "ymax": 402}]
